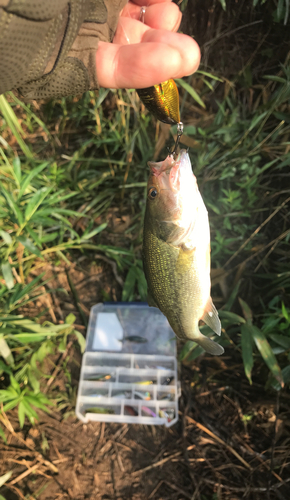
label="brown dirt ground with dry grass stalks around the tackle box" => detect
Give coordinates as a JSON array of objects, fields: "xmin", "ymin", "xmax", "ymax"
[{"xmin": 0, "ymin": 260, "xmax": 290, "ymax": 500}]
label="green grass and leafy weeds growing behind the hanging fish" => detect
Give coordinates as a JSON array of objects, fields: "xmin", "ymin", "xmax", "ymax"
[{"xmin": 0, "ymin": 50, "xmax": 290, "ymax": 425}]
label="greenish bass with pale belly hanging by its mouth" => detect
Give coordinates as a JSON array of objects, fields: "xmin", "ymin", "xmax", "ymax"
[{"xmin": 143, "ymin": 150, "xmax": 224, "ymax": 355}]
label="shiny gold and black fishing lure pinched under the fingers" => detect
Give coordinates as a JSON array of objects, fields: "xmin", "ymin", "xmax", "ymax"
[{"xmin": 137, "ymin": 79, "xmax": 180, "ymax": 125}]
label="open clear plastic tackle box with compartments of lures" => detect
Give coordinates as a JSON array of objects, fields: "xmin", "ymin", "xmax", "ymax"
[{"xmin": 76, "ymin": 303, "xmax": 180, "ymax": 427}]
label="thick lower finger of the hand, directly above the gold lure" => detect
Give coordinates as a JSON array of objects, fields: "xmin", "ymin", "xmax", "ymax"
[{"xmin": 96, "ymin": 30, "xmax": 200, "ymax": 88}]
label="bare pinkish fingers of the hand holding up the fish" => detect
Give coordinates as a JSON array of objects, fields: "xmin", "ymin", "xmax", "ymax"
[{"xmin": 96, "ymin": 0, "xmax": 200, "ymax": 89}]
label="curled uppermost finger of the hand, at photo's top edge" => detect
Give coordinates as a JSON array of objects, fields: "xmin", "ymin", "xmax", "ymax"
[{"xmin": 121, "ymin": 2, "xmax": 182, "ymax": 31}]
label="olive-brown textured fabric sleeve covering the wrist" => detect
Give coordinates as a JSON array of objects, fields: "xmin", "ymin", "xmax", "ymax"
[{"xmin": 0, "ymin": 0, "xmax": 127, "ymax": 99}]
